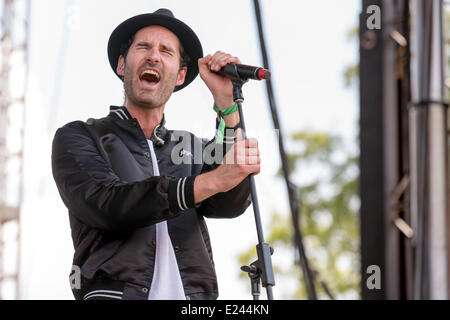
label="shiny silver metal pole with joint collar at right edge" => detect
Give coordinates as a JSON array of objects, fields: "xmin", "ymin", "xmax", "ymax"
[{"xmin": 410, "ymin": 0, "xmax": 448, "ymax": 299}]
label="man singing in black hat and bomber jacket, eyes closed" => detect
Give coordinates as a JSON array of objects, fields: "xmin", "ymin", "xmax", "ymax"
[{"xmin": 52, "ymin": 9, "xmax": 260, "ymax": 300}]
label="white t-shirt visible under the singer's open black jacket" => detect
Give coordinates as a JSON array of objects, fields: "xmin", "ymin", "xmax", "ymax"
[{"xmin": 147, "ymin": 140, "xmax": 186, "ymax": 300}]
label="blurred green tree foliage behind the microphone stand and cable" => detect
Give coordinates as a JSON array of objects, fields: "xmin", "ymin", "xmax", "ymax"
[{"xmin": 239, "ymin": 131, "xmax": 360, "ymax": 299}]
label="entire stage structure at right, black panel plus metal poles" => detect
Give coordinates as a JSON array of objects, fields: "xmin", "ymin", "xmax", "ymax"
[{"xmin": 360, "ymin": 0, "xmax": 450, "ymax": 299}]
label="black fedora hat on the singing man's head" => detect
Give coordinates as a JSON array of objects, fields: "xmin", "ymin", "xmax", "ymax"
[{"xmin": 108, "ymin": 9, "xmax": 203, "ymax": 91}]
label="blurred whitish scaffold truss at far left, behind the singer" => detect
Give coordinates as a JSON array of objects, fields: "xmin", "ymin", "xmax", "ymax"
[{"xmin": 0, "ymin": 0, "xmax": 31, "ymax": 299}]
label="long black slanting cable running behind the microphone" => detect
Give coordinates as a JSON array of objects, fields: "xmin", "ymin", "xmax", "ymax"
[{"xmin": 253, "ymin": 0, "xmax": 317, "ymax": 300}]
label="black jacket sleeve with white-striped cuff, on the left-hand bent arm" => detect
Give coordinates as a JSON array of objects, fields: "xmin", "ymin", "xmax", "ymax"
[{"xmin": 52, "ymin": 121, "xmax": 195, "ymax": 231}]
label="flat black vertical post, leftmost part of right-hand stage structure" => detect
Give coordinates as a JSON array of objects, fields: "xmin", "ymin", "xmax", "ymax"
[{"xmin": 359, "ymin": 0, "xmax": 387, "ymax": 300}]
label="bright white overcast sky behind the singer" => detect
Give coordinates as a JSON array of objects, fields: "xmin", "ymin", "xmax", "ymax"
[{"xmin": 0, "ymin": 0, "xmax": 360, "ymax": 299}]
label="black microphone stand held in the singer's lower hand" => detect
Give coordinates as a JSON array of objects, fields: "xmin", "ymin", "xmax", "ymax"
[{"xmin": 232, "ymin": 79, "xmax": 275, "ymax": 300}]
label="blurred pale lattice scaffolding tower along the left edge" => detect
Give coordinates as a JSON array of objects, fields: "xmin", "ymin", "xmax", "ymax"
[{"xmin": 0, "ymin": 0, "xmax": 31, "ymax": 299}]
